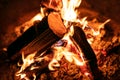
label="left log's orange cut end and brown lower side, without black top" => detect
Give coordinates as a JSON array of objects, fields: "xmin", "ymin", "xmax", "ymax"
[{"xmin": 21, "ymin": 12, "xmax": 67, "ymax": 54}]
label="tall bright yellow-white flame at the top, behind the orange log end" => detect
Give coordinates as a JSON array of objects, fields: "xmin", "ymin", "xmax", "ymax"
[{"xmin": 61, "ymin": 0, "xmax": 81, "ymax": 27}]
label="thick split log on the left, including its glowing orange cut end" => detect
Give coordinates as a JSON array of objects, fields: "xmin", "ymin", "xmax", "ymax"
[{"xmin": 7, "ymin": 13, "xmax": 66, "ymax": 58}]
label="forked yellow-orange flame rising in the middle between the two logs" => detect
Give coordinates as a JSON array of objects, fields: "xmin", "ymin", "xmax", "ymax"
[{"xmin": 48, "ymin": 26, "xmax": 85, "ymax": 70}]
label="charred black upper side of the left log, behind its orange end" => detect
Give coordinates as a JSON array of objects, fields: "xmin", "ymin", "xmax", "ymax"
[{"xmin": 7, "ymin": 17, "xmax": 49, "ymax": 57}]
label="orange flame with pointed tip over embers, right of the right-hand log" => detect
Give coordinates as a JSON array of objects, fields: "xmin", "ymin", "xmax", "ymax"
[{"xmin": 82, "ymin": 19, "xmax": 110, "ymax": 45}]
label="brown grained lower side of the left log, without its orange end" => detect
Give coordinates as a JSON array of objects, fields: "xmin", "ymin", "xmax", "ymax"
[{"xmin": 21, "ymin": 28, "xmax": 60, "ymax": 54}]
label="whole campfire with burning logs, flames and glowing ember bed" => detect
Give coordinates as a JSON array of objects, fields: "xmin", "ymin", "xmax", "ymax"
[{"xmin": 0, "ymin": 0, "xmax": 120, "ymax": 80}]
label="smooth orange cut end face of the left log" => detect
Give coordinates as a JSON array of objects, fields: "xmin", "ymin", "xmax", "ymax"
[{"xmin": 48, "ymin": 12, "xmax": 67, "ymax": 37}]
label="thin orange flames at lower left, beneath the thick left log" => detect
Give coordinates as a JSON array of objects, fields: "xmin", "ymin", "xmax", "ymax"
[{"xmin": 16, "ymin": 52, "xmax": 49, "ymax": 80}]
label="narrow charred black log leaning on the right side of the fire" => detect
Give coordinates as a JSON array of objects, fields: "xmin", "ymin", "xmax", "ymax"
[{"xmin": 73, "ymin": 26, "xmax": 101, "ymax": 80}]
